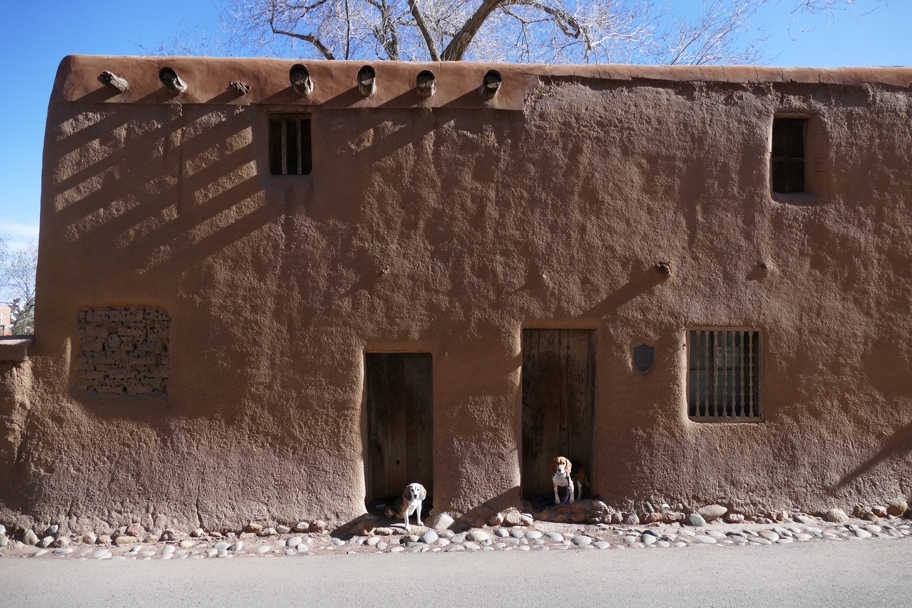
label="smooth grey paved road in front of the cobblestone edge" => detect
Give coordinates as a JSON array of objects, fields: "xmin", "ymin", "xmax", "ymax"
[{"xmin": 0, "ymin": 539, "xmax": 912, "ymax": 608}]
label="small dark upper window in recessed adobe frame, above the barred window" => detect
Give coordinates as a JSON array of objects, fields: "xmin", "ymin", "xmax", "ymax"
[{"xmin": 769, "ymin": 115, "xmax": 829, "ymax": 205}]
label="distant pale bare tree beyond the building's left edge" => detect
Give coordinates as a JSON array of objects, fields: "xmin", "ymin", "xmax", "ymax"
[{"xmin": 0, "ymin": 236, "xmax": 38, "ymax": 335}]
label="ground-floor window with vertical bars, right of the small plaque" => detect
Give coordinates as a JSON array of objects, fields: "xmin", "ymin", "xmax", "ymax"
[{"xmin": 687, "ymin": 329, "xmax": 763, "ymax": 422}]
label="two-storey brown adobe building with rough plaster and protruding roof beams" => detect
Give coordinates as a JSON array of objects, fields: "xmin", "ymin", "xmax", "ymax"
[{"xmin": 0, "ymin": 56, "xmax": 912, "ymax": 530}]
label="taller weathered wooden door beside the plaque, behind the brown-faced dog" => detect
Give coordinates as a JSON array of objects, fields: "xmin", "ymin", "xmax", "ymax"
[{"xmin": 522, "ymin": 329, "xmax": 596, "ymax": 495}]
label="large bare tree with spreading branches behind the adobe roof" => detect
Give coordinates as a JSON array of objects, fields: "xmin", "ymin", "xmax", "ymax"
[{"xmin": 175, "ymin": 0, "xmax": 887, "ymax": 64}]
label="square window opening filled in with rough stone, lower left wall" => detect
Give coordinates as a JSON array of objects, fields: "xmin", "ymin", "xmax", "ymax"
[{"xmin": 76, "ymin": 306, "xmax": 171, "ymax": 395}]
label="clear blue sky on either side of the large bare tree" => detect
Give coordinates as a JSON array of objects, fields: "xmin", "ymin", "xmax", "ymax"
[{"xmin": 0, "ymin": 0, "xmax": 912, "ymax": 248}]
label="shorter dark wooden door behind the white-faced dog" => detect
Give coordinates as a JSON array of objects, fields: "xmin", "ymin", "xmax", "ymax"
[{"xmin": 365, "ymin": 353, "xmax": 434, "ymax": 500}]
